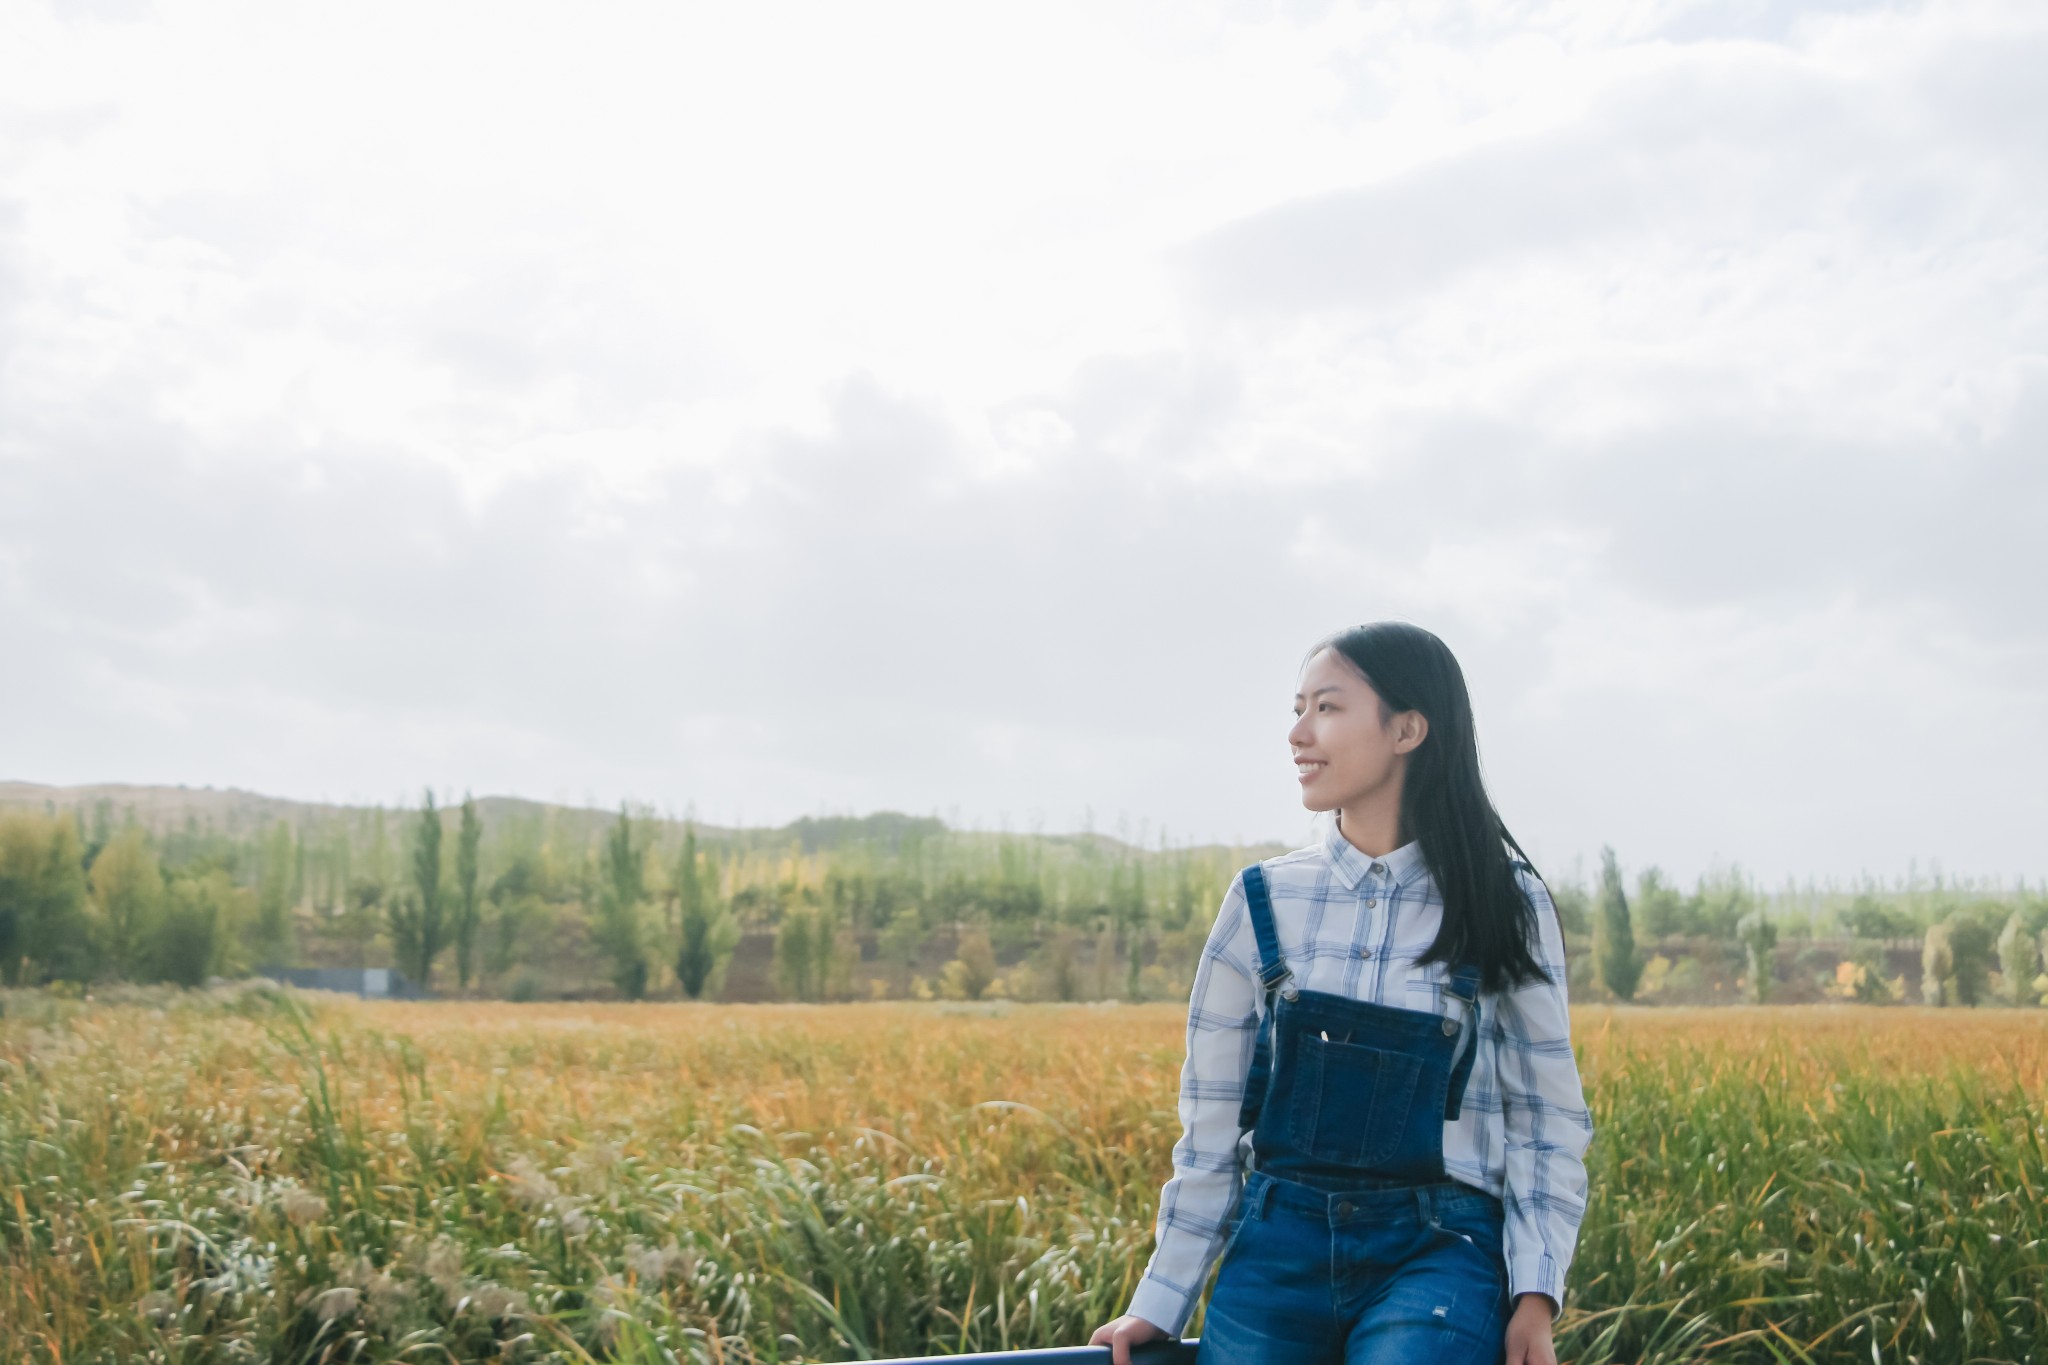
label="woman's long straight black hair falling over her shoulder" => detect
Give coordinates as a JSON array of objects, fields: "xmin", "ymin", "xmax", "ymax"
[{"xmin": 1309, "ymin": 620, "xmax": 1548, "ymax": 993}]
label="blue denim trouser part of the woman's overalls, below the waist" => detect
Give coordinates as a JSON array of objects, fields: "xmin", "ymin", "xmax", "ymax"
[{"xmin": 1196, "ymin": 1171, "xmax": 1509, "ymax": 1365}]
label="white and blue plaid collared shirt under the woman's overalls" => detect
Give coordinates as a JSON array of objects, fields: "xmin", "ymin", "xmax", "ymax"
[{"xmin": 1130, "ymin": 821, "xmax": 1593, "ymax": 1334}]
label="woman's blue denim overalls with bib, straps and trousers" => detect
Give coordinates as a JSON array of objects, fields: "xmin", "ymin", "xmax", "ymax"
[{"xmin": 1198, "ymin": 864, "xmax": 1507, "ymax": 1365}]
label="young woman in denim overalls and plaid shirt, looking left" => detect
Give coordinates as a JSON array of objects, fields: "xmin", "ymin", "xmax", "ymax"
[{"xmin": 1094, "ymin": 622, "xmax": 1593, "ymax": 1365}]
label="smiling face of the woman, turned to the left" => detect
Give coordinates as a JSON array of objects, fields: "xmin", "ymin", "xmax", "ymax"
[{"xmin": 1286, "ymin": 649, "xmax": 1427, "ymax": 810}]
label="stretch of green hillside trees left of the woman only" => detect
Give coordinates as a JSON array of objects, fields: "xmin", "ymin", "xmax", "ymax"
[{"xmin": 0, "ymin": 792, "xmax": 1278, "ymax": 1001}]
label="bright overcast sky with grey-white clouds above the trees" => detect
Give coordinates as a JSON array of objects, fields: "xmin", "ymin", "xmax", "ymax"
[{"xmin": 0, "ymin": 0, "xmax": 2048, "ymax": 882}]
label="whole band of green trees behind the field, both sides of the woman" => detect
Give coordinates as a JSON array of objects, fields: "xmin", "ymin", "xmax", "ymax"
[{"xmin": 0, "ymin": 792, "xmax": 2048, "ymax": 1005}]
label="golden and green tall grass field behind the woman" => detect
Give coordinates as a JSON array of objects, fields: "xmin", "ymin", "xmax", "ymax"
[{"xmin": 0, "ymin": 990, "xmax": 2048, "ymax": 1365}]
